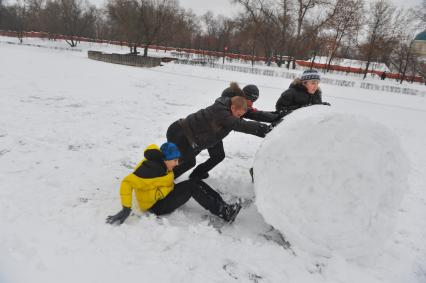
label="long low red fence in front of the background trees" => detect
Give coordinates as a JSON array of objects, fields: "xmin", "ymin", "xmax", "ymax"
[{"xmin": 0, "ymin": 30, "xmax": 424, "ymax": 83}]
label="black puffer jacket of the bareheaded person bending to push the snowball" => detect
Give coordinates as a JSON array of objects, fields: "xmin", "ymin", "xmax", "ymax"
[{"xmin": 185, "ymin": 97, "xmax": 268, "ymax": 150}]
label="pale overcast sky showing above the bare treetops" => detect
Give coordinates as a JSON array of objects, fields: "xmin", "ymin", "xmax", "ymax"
[{"xmin": 177, "ymin": 0, "xmax": 422, "ymax": 17}]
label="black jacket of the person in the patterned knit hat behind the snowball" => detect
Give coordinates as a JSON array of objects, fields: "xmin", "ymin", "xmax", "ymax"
[{"xmin": 275, "ymin": 79, "xmax": 322, "ymax": 111}]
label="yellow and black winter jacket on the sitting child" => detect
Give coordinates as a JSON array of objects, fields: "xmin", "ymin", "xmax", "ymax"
[{"xmin": 120, "ymin": 144, "xmax": 174, "ymax": 211}]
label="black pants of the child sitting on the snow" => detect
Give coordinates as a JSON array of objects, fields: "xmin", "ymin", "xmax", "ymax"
[{"xmin": 149, "ymin": 180, "xmax": 226, "ymax": 216}]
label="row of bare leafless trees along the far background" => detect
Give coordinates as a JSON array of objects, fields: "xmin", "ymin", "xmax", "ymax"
[{"xmin": 0, "ymin": 0, "xmax": 426, "ymax": 79}]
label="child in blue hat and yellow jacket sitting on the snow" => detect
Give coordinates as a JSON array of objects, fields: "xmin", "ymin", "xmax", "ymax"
[{"xmin": 106, "ymin": 142, "xmax": 241, "ymax": 224}]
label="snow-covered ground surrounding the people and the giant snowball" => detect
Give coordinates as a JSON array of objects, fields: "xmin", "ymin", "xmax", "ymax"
[{"xmin": 0, "ymin": 38, "xmax": 426, "ymax": 283}]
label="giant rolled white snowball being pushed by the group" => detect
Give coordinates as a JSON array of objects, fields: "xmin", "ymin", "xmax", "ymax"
[{"xmin": 254, "ymin": 106, "xmax": 408, "ymax": 259}]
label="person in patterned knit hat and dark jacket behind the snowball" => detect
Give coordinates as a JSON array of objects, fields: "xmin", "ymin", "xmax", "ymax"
[{"xmin": 275, "ymin": 70, "xmax": 330, "ymax": 112}]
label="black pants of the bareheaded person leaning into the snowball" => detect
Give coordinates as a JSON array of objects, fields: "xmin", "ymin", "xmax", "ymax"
[{"xmin": 167, "ymin": 121, "xmax": 225, "ymax": 178}]
